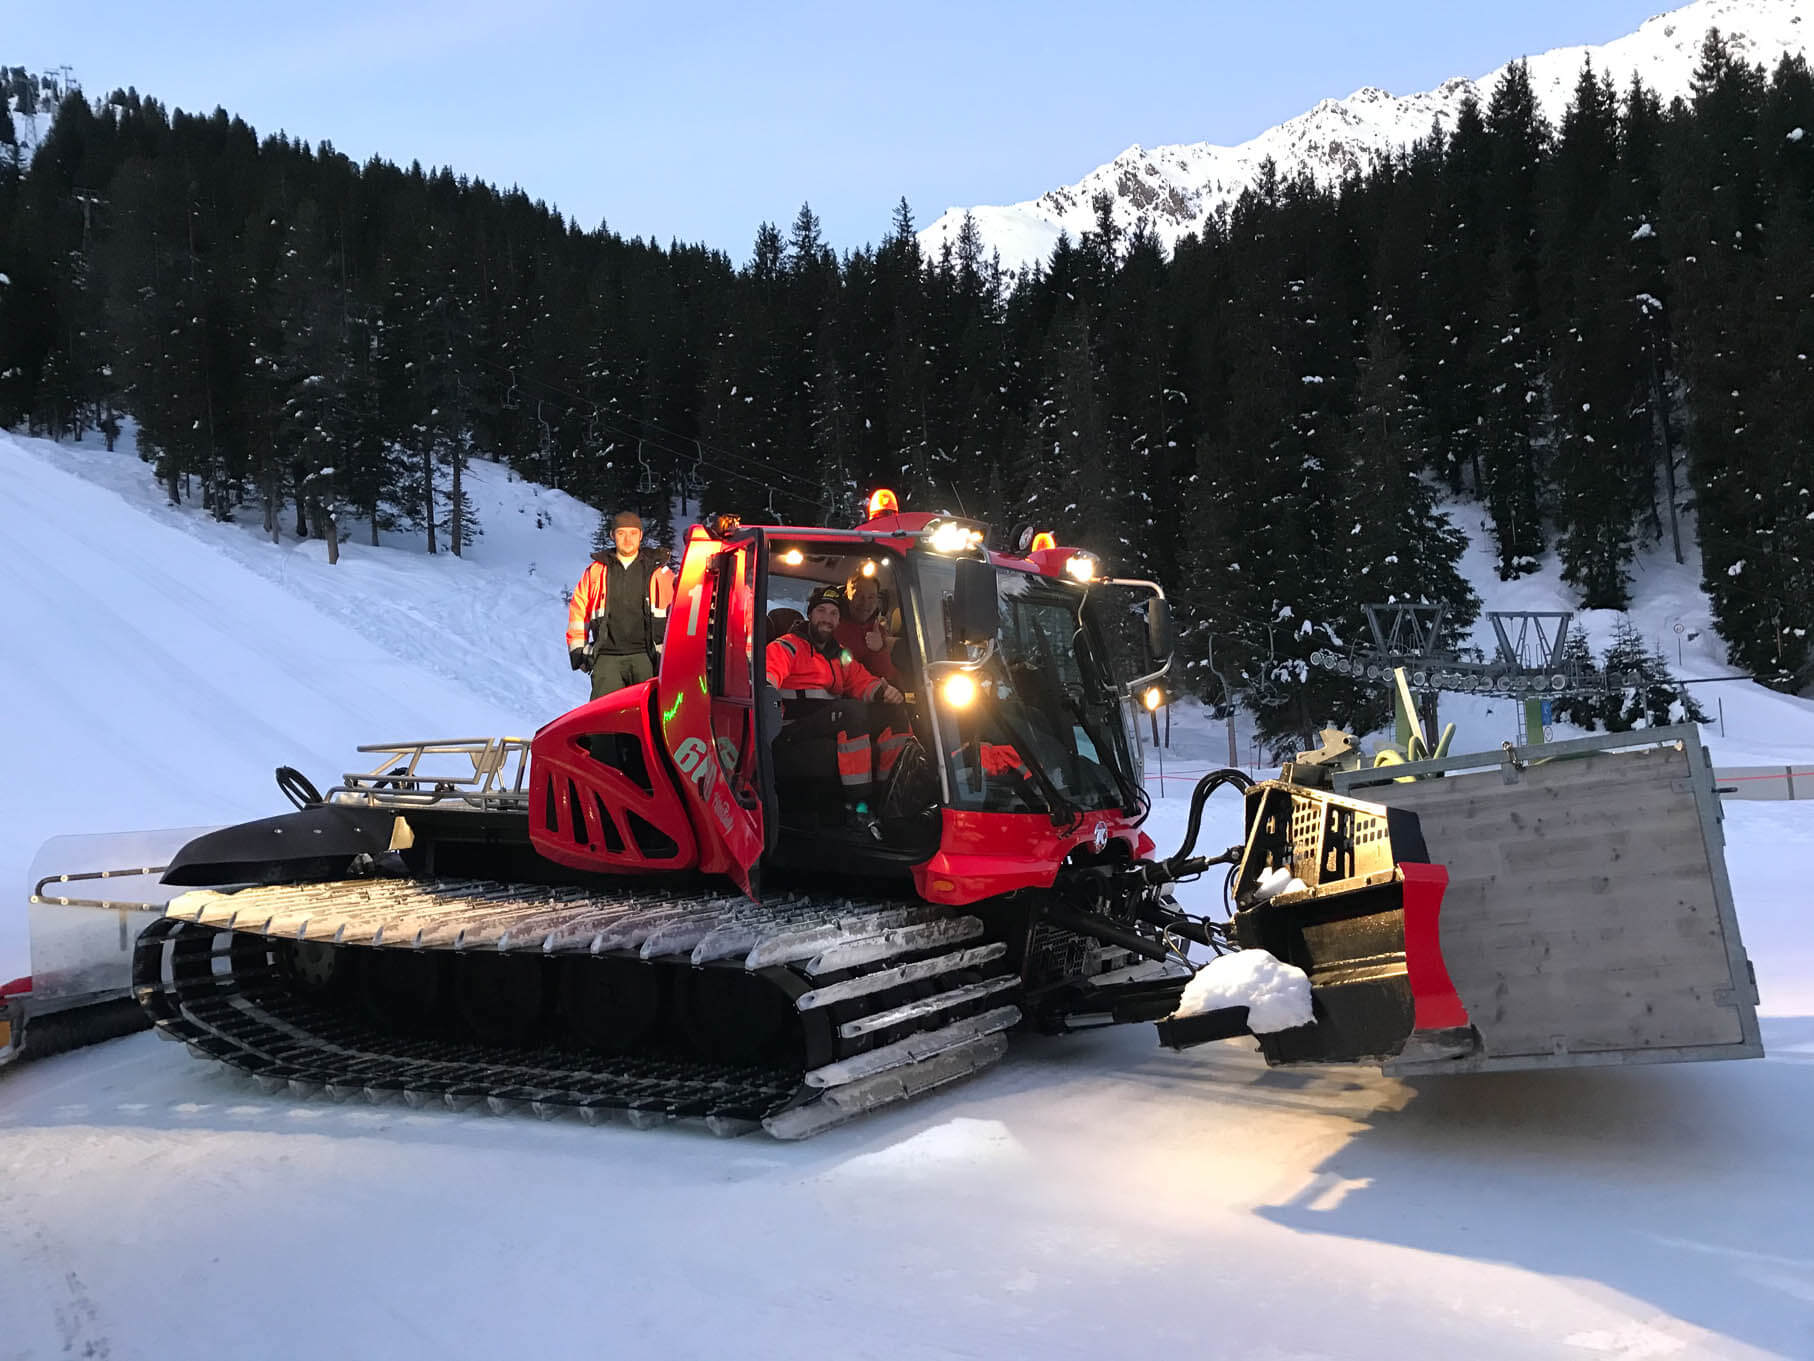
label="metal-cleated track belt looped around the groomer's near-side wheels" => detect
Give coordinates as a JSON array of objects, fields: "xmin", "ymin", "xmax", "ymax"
[{"xmin": 134, "ymin": 880, "xmax": 1019, "ymax": 1138}]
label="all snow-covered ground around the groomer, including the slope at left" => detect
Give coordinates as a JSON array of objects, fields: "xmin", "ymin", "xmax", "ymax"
[{"xmin": 0, "ymin": 434, "xmax": 1814, "ymax": 1361}]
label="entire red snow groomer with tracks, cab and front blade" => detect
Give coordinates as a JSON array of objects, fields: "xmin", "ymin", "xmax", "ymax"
[{"xmin": 17, "ymin": 492, "xmax": 1761, "ymax": 1138}]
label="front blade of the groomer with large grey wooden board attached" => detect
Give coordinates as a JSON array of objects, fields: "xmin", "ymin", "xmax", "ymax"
[{"xmin": 1284, "ymin": 726, "xmax": 1763, "ymax": 1074}]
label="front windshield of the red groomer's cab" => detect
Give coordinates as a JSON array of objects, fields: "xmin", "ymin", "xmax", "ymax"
[{"xmin": 912, "ymin": 553, "xmax": 1143, "ymax": 813}]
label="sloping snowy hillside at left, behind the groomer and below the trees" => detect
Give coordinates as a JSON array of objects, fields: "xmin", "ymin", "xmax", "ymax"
[{"xmin": 0, "ymin": 434, "xmax": 597, "ymax": 982}]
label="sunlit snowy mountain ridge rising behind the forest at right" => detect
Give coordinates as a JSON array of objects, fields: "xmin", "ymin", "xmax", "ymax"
[{"xmin": 920, "ymin": 0, "xmax": 1814, "ymax": 276}]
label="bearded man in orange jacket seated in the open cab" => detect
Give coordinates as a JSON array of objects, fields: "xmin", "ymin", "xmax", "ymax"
[{"xmin": 764, "ymin": 586, "xmax": 912, "ymax": 840}]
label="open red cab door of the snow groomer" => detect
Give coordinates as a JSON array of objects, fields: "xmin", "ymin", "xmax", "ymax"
[{"xmin": 658, "ymin": 530, "xmax": 771, "ymax": 896}]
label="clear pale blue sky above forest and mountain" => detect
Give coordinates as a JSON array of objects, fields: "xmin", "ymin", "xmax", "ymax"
[{"xmin": 10, "ymin": 0, "xmax": 1667, "ymax": 261}]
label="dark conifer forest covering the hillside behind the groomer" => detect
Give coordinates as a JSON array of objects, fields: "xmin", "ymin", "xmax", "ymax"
[{"xmin": 0, "ymin": 33, "xmax": 1814, "ymax": 747}]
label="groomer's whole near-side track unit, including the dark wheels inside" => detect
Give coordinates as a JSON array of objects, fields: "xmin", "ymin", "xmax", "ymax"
[{"xmin": 134, "ymin": 878, "xmax": 1019, "ymax": 1138}]
